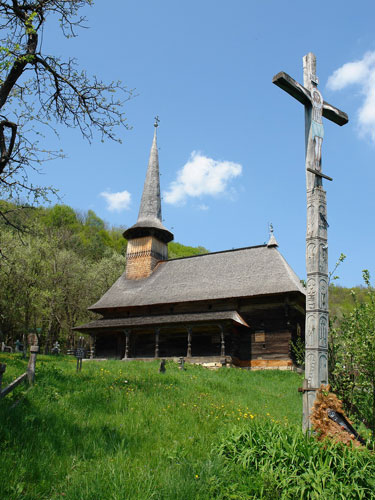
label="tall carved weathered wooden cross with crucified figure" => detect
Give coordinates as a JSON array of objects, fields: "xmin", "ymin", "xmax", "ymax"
[{"xmin": 272, "ymin": 52, "xmax": 348, "ymax": 431}]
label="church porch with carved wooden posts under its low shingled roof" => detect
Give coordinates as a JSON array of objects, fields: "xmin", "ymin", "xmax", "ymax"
[{"xmin": 73, "ymin": 311, "xmax": 249, "ymax": 363}]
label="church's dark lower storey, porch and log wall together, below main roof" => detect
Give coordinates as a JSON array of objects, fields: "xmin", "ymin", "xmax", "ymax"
[{"xmin": 75, "ymin": 306, "xmax": 301, "ymax": 370}]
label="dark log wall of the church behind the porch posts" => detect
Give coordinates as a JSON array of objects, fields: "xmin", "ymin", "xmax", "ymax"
[{"xmin": 93, "ymin": 294, "xmax": 304, "ymax": 361}]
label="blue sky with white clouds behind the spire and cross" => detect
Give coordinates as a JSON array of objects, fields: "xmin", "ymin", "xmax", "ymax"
[{"xmin": 27, "ymin": 0, "xmax": 375, "ymax": 286}]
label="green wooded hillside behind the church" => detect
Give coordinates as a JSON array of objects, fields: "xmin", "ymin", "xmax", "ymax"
[{"xmin": 0, "ymin": 201, "xmax": 366, "ymax": 351}]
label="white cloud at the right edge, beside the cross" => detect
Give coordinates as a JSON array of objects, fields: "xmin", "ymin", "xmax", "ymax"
[{"xmin": 327, "ymin": 52, "xmax": 375, "ymax": 142}]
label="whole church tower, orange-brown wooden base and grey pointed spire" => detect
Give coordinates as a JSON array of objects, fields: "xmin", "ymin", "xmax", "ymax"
[{"xmin": 124, "ymin": 117, "xmax": 173, "ymax": 279}]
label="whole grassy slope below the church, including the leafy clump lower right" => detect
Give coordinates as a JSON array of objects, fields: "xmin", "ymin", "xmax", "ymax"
[{"xmin": 0, "ymin": 353, "xmax": 375, "ymax": 500}]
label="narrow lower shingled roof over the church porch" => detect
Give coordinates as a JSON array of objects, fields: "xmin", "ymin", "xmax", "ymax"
[{"xmin": 73, "ymin": 311, "xmax": 249, "ymax": 331}]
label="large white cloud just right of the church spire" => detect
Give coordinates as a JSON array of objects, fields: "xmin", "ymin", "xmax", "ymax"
[{"xmin": 163, "ymin": 151, "xmax": 242, "ymax": 205}]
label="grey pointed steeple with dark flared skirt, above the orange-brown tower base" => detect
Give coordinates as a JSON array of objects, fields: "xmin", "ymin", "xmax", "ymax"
[{"xmin": 124, "ymin": 117, "xmax": 173, "ymax": 243}]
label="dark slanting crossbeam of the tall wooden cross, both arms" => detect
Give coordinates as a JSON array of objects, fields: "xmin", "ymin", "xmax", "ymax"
[{"xmin": 272, "ymin": 71, "xmax": 349, "ymax": 126}]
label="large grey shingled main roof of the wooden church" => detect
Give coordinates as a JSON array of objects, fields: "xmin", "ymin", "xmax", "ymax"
[{"xmin": 89, "ymin": 245, "xmax": 305, "ymax": 312}]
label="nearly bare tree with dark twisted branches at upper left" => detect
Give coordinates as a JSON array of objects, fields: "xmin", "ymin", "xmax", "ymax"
[{"xmin": 0, "ymin": 0, "xmax": 131, "ymax": 222}]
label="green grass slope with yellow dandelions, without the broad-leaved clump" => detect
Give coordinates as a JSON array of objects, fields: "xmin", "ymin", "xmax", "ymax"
[{"xmin": 0, "ymin": 354, "xmax": 301, "ymax": 500}]
